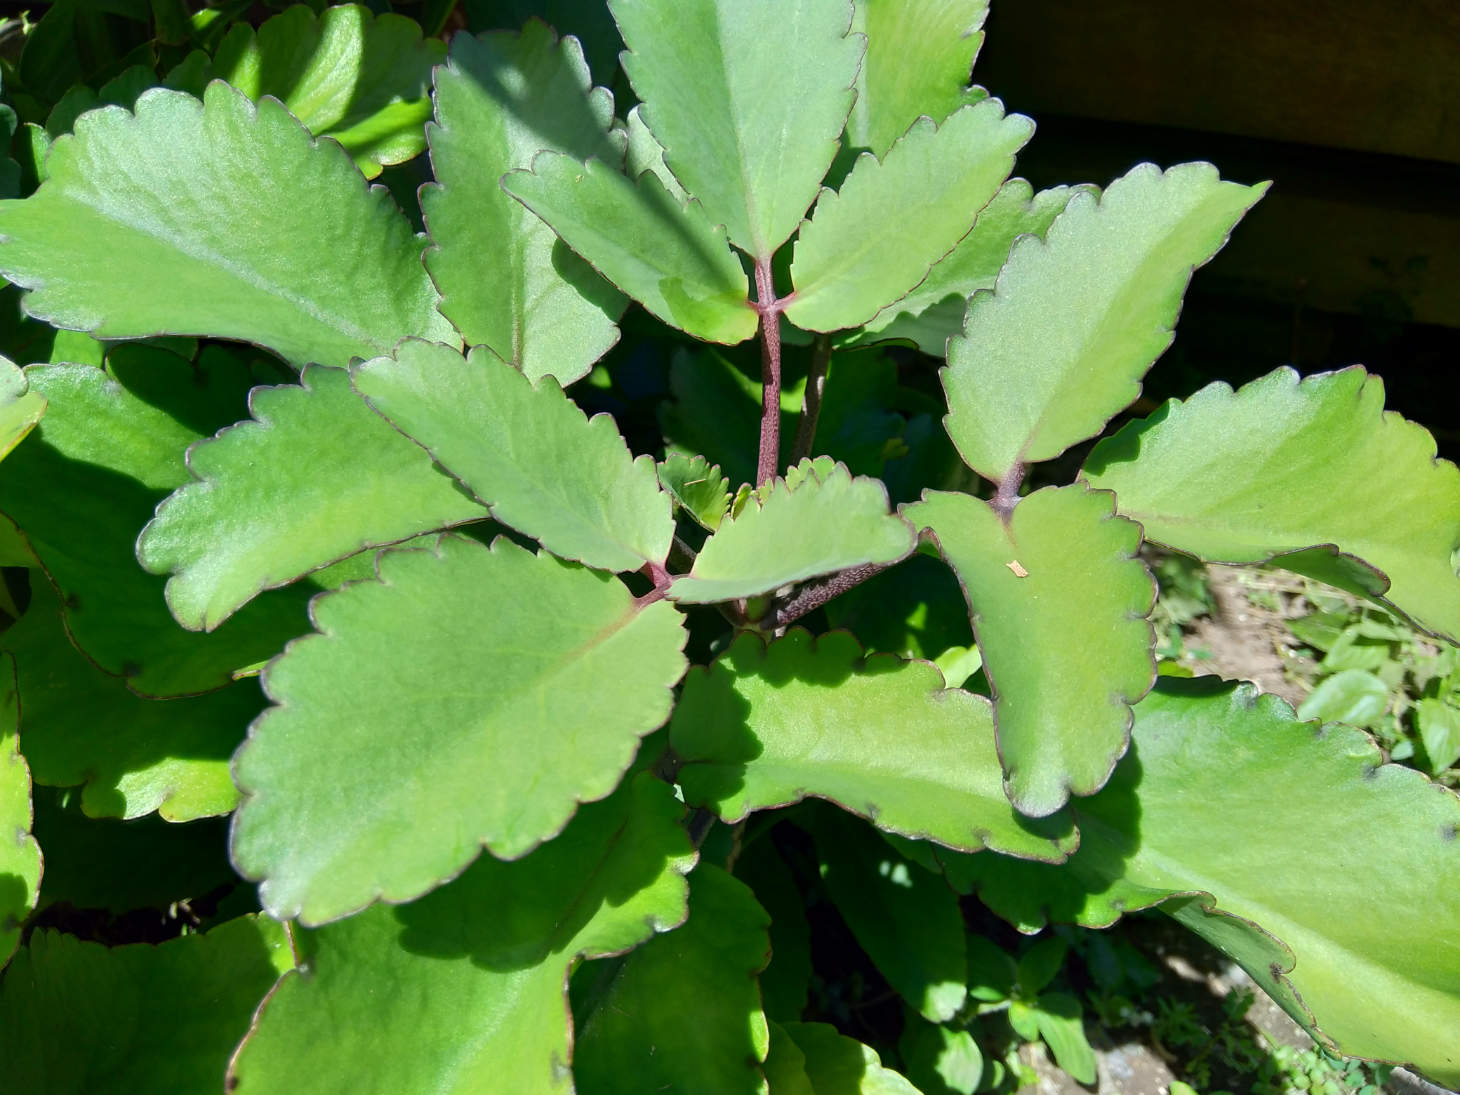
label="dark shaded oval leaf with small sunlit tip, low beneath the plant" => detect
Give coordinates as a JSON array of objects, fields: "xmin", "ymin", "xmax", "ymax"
[{"xmin": 810, "ymin": 812, "xmax": 968, "ymax": 1022}]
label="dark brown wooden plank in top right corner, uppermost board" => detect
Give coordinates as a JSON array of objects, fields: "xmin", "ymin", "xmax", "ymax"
[{"xmin": 975, "ymin": 0, "xmax": 1460, "ymax": 164}]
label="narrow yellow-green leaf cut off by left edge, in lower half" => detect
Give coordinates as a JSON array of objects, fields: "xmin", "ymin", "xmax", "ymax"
[{"xmin": 0, "ymin": 654, "xmax": 41, "ymax": 969}]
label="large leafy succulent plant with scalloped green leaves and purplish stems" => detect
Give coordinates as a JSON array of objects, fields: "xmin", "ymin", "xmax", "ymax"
[{"xmin": 0, "ymin": 0, "xmax": 1460, "ymax": 1095}]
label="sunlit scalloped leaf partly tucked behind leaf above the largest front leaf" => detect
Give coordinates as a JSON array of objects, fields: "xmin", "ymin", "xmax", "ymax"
[{"xmin": 137, "ymin": 365, "xmax": 486, "ymax": 631}]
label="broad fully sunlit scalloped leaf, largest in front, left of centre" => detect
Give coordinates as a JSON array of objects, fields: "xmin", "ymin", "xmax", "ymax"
[{"xmin": 234, "ymin": 536, "xmax": 685, "ymax": 924}]
